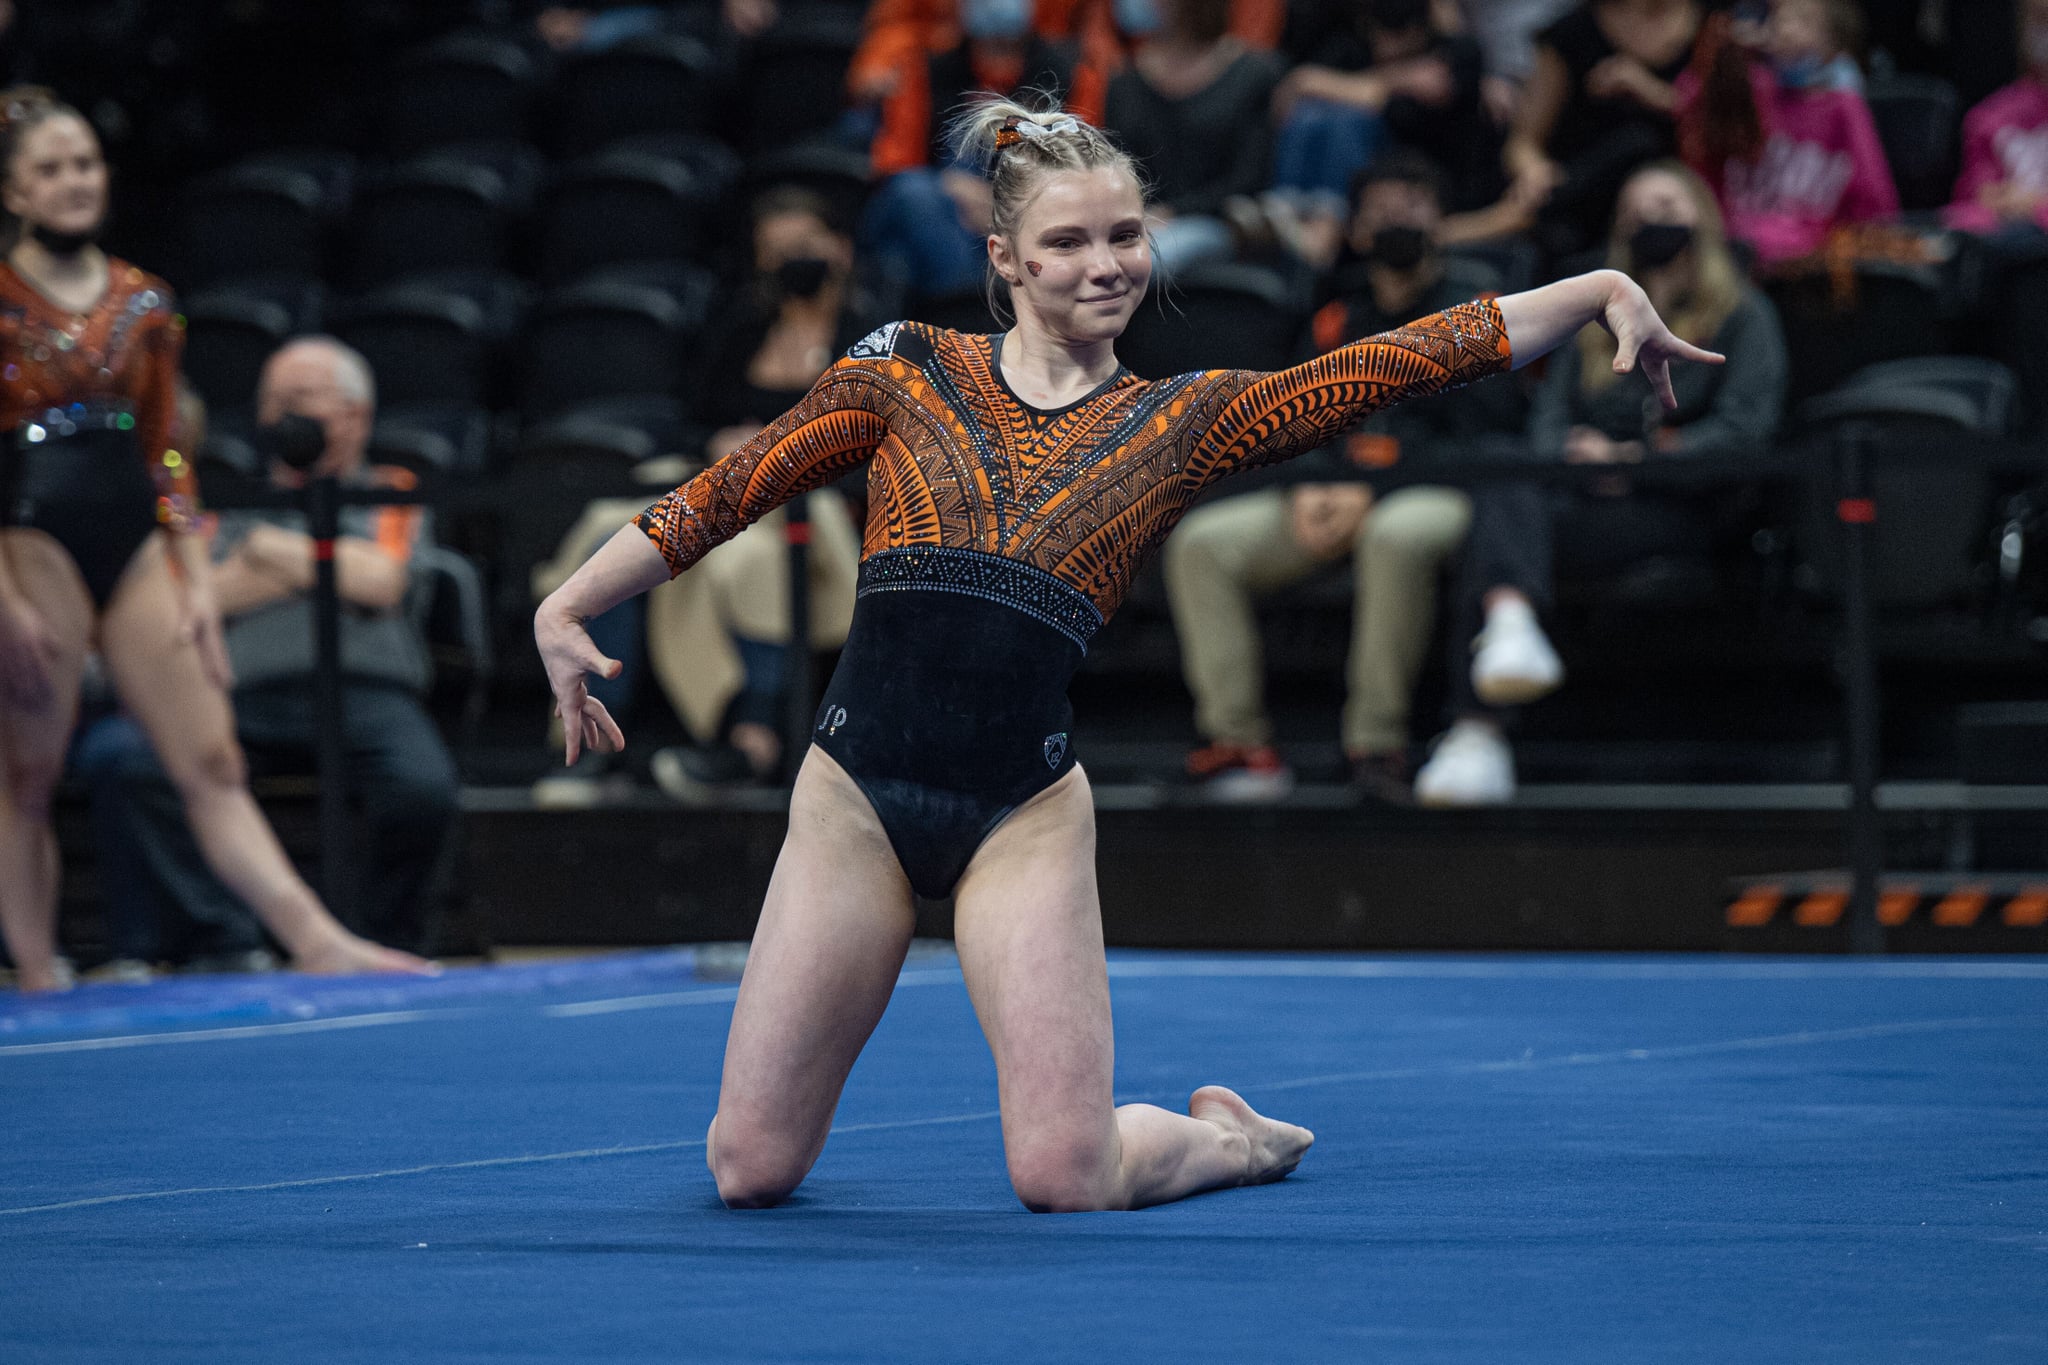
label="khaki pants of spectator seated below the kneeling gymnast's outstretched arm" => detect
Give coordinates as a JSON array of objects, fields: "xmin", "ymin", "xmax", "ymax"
[{"xmin": 1165, "ymin": 487, "xmax": 1473, "ymax": 755}]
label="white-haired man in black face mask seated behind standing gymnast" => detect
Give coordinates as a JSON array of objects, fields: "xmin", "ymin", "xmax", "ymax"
[{"xmin": 86, "ymin": 336, "xmax": 459, "ymax": 945}]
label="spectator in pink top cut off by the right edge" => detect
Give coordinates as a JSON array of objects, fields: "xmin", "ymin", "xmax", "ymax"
[{"xmin": 1948, "ymin": 0, "xmax": 2048, "ymax": 250}]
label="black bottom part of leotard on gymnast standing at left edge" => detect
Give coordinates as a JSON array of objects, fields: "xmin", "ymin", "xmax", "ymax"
[{"xmin": 0, "ymin": 417, "xmax": 158, "ymax": 608}]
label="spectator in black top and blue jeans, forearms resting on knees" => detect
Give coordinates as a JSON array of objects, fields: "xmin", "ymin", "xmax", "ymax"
[{"xmin": 1274, "ymin": 0, "xmax": 1499, "ymax": 240}]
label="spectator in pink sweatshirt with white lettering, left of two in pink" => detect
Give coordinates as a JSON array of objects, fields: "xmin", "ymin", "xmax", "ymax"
[{"xmin": 1679, "ymin": 0, "xmax": 1898, "ymax": 268}]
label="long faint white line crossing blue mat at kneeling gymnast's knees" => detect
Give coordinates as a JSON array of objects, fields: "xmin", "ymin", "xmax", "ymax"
[{"xmin": 0, "ymin": 1015, "xmax": 2048, "ymax": 1218}]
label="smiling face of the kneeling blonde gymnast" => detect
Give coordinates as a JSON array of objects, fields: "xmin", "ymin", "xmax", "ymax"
[{"xmin": 989, "ymin": 166, "xmax": 1151, "ymax": 342}]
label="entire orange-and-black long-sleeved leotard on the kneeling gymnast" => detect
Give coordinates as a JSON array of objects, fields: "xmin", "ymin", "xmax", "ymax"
[{"xmin": 639, "ymin": 301, "xmax": 1509, "ymax": 896}]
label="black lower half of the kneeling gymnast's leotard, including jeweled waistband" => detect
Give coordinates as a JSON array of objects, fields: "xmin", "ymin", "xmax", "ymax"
[{"xmin": 813, "ymin": 546, "xmax": 1102, "ymax": 898}]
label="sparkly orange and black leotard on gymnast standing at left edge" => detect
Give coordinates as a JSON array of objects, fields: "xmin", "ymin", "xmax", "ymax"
[{"xmin": 0, "ymin": 260, "xmax": 199, "ymax": 606}]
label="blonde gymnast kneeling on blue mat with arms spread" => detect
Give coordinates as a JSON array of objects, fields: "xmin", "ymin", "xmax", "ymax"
[{"xmin": 535, "ymin": 102, "xmax": 1718, "ymax": 1209}]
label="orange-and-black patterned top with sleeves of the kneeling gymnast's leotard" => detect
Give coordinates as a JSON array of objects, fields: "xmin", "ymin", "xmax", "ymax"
[{"xmin": 639, "ymin": 301, "xmax": 1509, "ymax": 618}]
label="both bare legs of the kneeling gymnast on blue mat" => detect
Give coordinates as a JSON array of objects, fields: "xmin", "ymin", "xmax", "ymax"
[{"xmin": 707, "ymin": 749, "xmax": 1315, "ymax": 1212}]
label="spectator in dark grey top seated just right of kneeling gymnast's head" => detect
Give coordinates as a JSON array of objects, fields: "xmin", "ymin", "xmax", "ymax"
[{"xmin": 1104, "ymin": 0, "xmax": 1282, "ymax": 272}]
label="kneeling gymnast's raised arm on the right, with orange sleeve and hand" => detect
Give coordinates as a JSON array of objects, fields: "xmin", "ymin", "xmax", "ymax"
[{"xmin": 1186, "ymin": 270, "xmax": 1720, "ymax": 485}]
